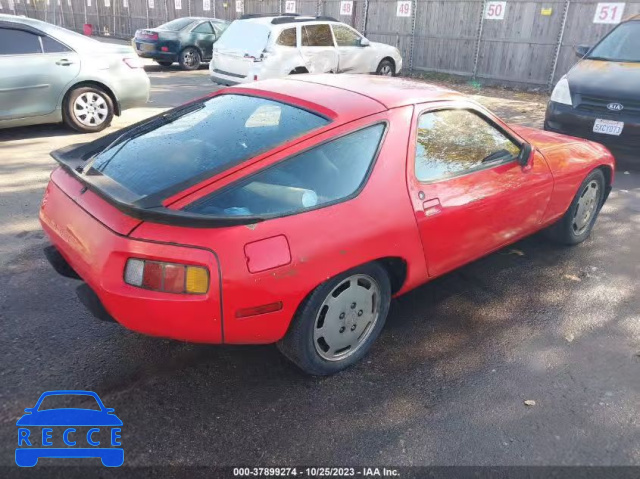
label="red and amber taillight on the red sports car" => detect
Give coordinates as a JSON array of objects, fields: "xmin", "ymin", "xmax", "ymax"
[{"xmin": 124, "ymin": 258, "xmax": 209, "ymax": 294}]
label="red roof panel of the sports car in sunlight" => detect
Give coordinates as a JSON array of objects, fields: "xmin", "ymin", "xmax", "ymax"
[{"xmin": 235, "ymin": 74, "xmax": 465, "ymax": 112}]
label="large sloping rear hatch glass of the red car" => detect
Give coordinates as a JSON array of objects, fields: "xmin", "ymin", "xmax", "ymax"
[{"xmin": 91, "ymin": 95, "xmax": 328, "ymax": 196}]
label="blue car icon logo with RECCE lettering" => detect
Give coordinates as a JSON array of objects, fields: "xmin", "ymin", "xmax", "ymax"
[{"xmin": 16, "ymin": 390, "xmax": 124, "ymax": 467}]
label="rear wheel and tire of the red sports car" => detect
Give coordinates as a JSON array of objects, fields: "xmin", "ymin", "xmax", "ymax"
[{"xmin": 277, "ymin": 263, "xmax": 391, "ymax": 376}]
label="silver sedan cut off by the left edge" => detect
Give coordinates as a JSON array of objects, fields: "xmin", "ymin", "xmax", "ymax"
[{"xmin": 0, "ymin": 14, "xmax": 150, "ymax": 132}]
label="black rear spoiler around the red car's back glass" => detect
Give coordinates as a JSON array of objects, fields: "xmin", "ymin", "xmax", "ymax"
[{"xmin": 51, "ymin": 114, "xmax": 264, "ymax": 228}]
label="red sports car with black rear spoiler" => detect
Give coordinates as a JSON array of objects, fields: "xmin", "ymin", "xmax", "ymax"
[{"xmin": 40, "ymin": 75, "xmax": 614, "ymax": 375}]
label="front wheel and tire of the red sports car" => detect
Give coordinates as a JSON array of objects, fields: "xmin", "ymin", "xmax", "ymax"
[{"xmin": 544, "ymin": 169, "xmax": 606, "ymax": 246}]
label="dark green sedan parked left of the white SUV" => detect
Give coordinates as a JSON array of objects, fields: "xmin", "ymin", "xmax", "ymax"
[{"xmin": 131, "ymin": 17, "xmax": 229, "ymax": 70}]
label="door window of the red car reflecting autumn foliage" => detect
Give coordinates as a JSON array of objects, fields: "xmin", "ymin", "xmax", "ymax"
[{"xmin": 415, "ymin": 110, "xmax": 520, "ymax": 182}]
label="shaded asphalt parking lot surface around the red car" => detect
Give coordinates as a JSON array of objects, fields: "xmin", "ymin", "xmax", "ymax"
[{"xmin": 0, "ymin": 53, "xmax": 640, "ymax": 466}]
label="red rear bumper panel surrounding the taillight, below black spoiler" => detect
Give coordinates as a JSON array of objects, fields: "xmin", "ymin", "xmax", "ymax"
[{"xmin": 40, "ymin": 168, "xmax": 223, "ymax": 343}]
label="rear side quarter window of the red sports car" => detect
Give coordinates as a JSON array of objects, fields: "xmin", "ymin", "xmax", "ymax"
[{"xmin": 185, "ymin": 124, "xmax": 385, "ymax": 216}]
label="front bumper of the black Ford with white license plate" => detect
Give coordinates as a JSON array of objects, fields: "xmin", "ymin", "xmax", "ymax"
[{"xmin": 544, "ymin": 102, "xmax": 640, "ymax": 164}]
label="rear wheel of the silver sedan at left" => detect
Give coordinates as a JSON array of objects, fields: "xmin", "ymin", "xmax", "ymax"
[{"xmin": 62, "ymin": 86, "xmax": 114, "ymax": 133}]
